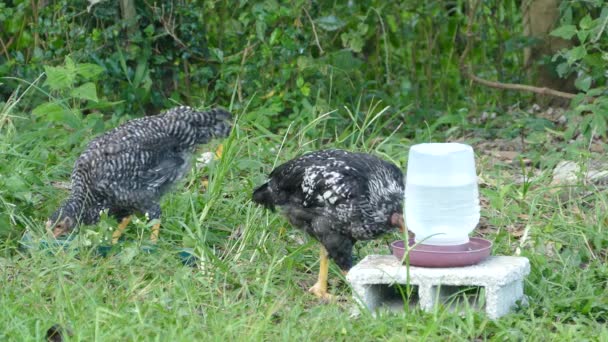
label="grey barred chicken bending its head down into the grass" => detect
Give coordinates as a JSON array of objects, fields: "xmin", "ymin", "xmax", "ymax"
[{"xmin": 46, "ymin": 106, "xmax": 232, "ymax": 243}]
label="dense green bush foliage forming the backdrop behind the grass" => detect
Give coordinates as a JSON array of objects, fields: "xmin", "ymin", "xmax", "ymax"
[{"xmin": 0, "ymin": 0, "xmax": 608, "ymax": 230}]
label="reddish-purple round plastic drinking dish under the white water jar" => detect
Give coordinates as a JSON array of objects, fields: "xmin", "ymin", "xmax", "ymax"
[{"xmin": 391, "ymin": 238, "xmax": 492, "ymax": 267}]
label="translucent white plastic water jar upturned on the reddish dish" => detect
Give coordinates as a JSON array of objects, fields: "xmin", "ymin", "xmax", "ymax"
[{"xmin": 405, "ymin": 143, "xmax": 479, "ymax": 246}]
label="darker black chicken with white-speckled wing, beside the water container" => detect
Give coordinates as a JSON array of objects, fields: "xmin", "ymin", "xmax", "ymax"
[{"xmin": 253, "ymin": 150, "xmax": 405, "ymax": 299}]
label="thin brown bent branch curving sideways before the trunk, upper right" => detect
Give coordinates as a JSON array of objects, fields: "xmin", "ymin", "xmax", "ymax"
[{"xmin": 459, "ymin": 0, "xmax": 577, "ymax": 99}]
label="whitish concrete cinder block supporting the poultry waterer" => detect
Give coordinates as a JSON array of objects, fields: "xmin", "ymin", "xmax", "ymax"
[{"xmin": 346, "ymin": 255, "xmax": 530, "ymax": 319}]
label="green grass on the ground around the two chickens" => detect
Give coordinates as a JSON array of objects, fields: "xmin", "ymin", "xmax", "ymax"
[{"xmin": 0, "ymin": 95, "xmax": 608, "ymax": 341}]
